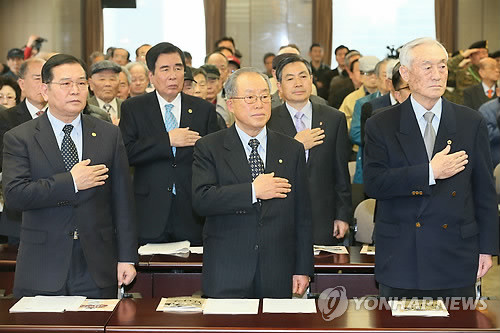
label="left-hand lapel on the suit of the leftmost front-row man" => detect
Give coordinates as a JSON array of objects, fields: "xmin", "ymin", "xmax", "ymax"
[{"xmin": 35, "ymin": 113, "xmax": 66, "ymax": 172}]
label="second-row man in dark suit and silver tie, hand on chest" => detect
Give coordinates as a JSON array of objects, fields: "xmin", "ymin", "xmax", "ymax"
[{"xmin": 268, "ymin": 55, "xmax": 352, "ymax": 245}]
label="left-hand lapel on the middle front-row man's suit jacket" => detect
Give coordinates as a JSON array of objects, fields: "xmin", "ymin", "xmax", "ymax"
[{"xmin": 224, "ymin": 125, "xmax": 252, "ymax": 183}]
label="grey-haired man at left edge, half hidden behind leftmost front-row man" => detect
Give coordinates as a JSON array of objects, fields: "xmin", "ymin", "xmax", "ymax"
[{"xmin": 0, "ymin": 58, "xmax": 47, "ymax": 244}]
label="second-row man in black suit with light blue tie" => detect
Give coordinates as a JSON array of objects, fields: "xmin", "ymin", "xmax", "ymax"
[{"xmin": 120, "ymin": 43, "xmax": 218, "ymax": 245}]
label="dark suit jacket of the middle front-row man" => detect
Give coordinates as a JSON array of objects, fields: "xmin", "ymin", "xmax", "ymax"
[{"xmin": 193, "ymin": 125, "xmax": 313, "ymax": 298}]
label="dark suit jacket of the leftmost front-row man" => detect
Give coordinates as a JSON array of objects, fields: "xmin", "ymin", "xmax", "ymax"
[{"xmin": 3, "ymin": 114, "xmax": 137, "ymax": 292}]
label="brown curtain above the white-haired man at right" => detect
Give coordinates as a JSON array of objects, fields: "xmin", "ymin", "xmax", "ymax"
[{"xmin": 434, "ymin": 0, "xmax": 457, "ymax": 53}]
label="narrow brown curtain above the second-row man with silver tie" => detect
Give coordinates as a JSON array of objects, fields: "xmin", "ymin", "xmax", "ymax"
[{"xmin": 312, "ymin": 0, "xmax": 333, "ymax": 66}]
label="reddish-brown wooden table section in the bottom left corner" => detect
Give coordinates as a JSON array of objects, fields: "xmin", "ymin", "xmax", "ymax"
[{"xmin": 0, "ymin": 299, "xmax": 111, "ymax": 333}]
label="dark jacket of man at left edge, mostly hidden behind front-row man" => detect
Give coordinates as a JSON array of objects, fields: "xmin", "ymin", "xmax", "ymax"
[{"xmin": 0, "ymin": 100, "xmax": 33, "ymax": 238}]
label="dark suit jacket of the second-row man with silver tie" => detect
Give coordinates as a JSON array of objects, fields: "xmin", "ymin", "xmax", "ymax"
[{"xmin": 267, "ymin": 103, "xmax": 352, "ymax": 245}]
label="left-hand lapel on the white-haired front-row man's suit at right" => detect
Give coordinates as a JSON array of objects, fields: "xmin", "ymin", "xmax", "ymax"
[{"xmin": 396, "ymin": 98, "xmax": 428, "ymax": 165}]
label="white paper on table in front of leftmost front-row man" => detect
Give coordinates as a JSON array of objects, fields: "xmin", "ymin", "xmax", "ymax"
[{"xmin": 9, "ymin": 296, "xmax": 86, "ymax": 313}]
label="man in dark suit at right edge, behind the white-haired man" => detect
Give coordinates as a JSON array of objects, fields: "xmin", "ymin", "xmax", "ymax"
[{"xmin": 464, "ymin": 58, "xmax": 500, "ymax": 110}]
